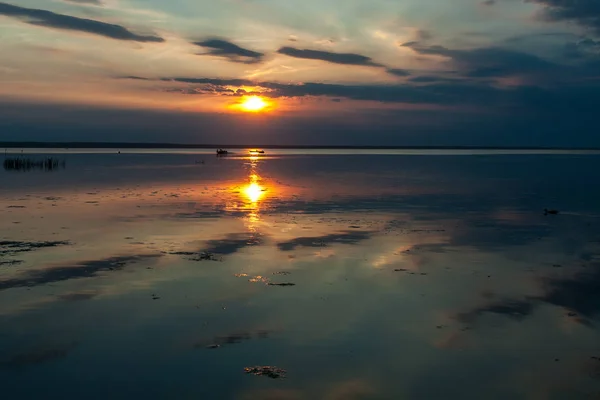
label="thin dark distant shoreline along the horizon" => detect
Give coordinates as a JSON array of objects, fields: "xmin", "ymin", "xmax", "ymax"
[{"xmin": 0, "ymin": 142, "xmax": 600, "ymax": 151}]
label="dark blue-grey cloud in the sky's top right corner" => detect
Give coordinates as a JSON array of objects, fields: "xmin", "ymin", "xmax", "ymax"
[{"xmin": 527, "ymin": 0, "xmax": 600, "ymax": 34}]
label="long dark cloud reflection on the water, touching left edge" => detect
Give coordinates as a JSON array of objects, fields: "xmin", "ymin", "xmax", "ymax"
[{"xmin": 0, "ymin": 255, "xmax": 159, "ymax": 290}]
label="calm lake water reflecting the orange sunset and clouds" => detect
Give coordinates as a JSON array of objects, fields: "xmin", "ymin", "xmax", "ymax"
[{"xmin": 0, "ymin": 150, "xmax": 600, "ymax": 400}]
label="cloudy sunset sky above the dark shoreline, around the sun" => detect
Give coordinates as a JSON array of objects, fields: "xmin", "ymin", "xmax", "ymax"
[{"xmin": 0, "ymin": 0, "xmax": 600, "ymax": 147}]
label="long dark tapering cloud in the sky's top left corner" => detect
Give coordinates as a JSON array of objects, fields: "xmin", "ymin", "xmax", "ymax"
[{"xmin": 0, "ymin": 2, "xmax": 165, "ymax": 42}]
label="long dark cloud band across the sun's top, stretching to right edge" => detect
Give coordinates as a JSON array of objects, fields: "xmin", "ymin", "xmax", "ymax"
[{"xmin": 157, "ymin": 72, "xmax": 600, "ymax": 112}]
